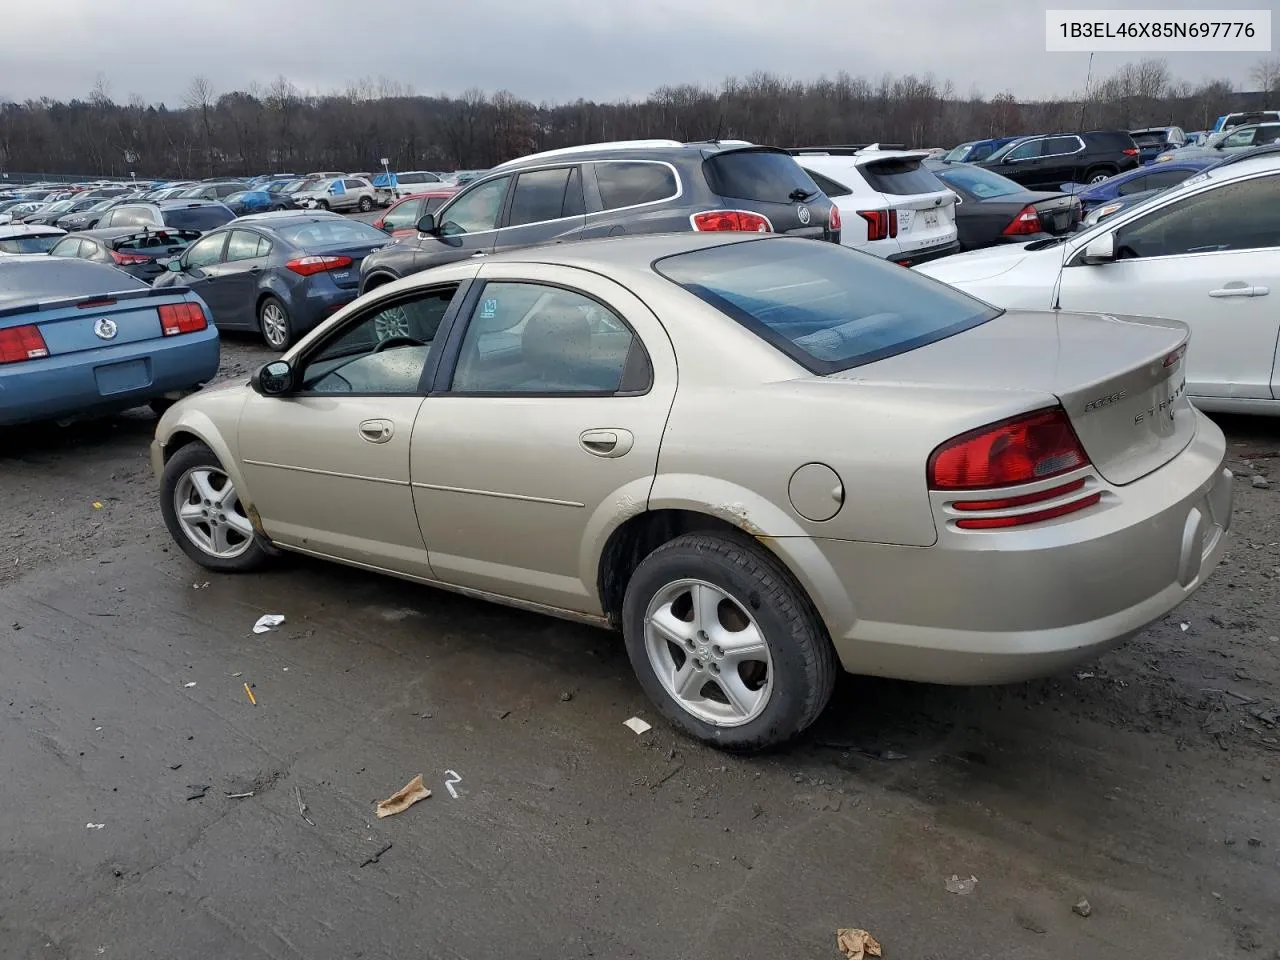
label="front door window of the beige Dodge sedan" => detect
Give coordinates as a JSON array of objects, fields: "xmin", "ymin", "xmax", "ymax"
[{"xmin": 301, "ymin": 285, "xmax": 457, "ymax": 396}]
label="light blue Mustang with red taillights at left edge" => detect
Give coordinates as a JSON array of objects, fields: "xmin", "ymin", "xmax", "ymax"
[{"xmin": 0, "ymin": 255, "xmax": 218, "ymax": 426}]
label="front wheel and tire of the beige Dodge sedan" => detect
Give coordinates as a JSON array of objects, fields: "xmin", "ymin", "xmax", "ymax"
[{"xmin": 160, "ymin": 443, "xmax": 270, "ymax": 573}]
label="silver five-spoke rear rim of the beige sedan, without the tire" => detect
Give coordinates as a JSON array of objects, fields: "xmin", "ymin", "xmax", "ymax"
[{"xmin": 644, "ymin": 580, "xmax": 773, "ymax": 727}]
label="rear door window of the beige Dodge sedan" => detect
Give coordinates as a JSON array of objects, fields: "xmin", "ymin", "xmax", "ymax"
[{"xmin": 452, "ymin": 282, "xmax": 649, "ymax": 396}]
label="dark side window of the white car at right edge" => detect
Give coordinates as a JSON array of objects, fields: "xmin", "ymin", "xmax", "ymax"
[{"xmin": 1116, "ymin": 175, "xmax": 1280, "ymax": 260}]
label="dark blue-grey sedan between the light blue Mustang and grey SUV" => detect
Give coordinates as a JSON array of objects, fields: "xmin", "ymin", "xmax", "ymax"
[{"xmin": 155, "ymin": 210, "xmax": 390, "ymax": 349}]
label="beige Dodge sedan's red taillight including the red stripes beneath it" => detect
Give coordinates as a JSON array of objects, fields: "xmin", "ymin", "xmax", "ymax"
[{"xmin": 928, "ymin": 407, "xmax": 1102, "ymax": 530}]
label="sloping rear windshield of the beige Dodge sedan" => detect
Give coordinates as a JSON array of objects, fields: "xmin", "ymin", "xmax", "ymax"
[{"xmin": 654, "ymin": 239, "xmax": 1001, "ymax": 374}]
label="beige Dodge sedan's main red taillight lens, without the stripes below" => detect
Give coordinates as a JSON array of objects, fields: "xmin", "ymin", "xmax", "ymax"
[{"xmin": 928, "ymin": 407, "xmax": 1089, "ymax": 490}]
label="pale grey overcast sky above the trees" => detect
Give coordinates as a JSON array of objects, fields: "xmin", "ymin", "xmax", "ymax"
[{"xmin": 0, "ymin": 0, "xmax": 1280, "ymax": 105}]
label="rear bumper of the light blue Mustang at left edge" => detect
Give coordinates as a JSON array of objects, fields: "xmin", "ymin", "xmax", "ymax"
[{"xmin": 0, "ymin": 326, "xmax": 219, "ymax": 426}]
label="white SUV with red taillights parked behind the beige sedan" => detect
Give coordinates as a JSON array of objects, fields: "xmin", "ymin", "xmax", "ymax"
[{"xmin": 792, "ymin": 143, "xmax": 959, "ymax": 266}]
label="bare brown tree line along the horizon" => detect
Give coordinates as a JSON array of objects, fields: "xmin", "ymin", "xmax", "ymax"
[{"xmin": 0, "ymin": 58, "xmax": 1280, "ymax": 178}]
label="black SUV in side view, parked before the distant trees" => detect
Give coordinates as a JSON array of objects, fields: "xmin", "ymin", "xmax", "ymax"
[{"xmin": 978, "ymin": 131, "xmax": 1138, "ymax": 189}]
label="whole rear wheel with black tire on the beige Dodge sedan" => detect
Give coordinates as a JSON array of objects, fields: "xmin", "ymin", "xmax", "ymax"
[{"xmin": 622, "ymin": 534, "xmax": 836, "ymax": 751}]
